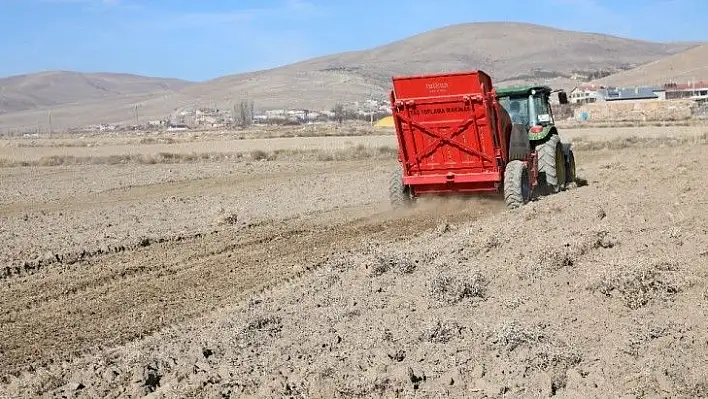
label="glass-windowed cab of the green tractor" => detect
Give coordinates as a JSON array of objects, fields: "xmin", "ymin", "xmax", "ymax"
[{"xmin": 496, "ymin": 86, "xmax": 568, "ymax": 134}]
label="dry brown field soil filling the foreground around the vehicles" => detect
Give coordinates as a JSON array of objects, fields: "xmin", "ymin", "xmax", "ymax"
[{"xmin": 0, "ymin": 130, "xmax": 708, "ymax": 398}]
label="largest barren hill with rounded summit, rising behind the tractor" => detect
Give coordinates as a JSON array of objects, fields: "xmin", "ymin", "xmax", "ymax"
[{"xmin": 180, "ymin": 23, "xmax": 691, "ymax": 108}]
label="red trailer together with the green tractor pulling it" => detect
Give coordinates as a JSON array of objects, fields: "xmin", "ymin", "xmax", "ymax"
[{"xmin": 389, "ymin": 70, "xmax": 575, "ymax": 208}]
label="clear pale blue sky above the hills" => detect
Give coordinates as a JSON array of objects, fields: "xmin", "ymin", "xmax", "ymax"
[{"xmin": 0, "ymin": 0, "xmax": 708, "ymax": 81}]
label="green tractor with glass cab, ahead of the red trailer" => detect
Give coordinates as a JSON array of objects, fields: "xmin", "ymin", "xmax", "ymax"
[{"xmin": 496, "ymin": 85, "xmax": 576, "ymax": 194}]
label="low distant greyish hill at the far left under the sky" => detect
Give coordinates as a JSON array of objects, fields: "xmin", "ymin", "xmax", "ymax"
[{"xmin": 0, "ymin": 71, "xmax": 189, "ymax": 114}]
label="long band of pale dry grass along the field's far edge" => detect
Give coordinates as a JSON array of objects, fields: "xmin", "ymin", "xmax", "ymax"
[{"xmin": 0, "ymin": 129, "xmax": 708, "ymax": 167}]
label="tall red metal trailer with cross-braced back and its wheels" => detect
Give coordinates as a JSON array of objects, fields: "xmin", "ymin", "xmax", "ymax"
[{"xmin": 390, "ymin": 71, "xmax": 538, "ymax": 207}]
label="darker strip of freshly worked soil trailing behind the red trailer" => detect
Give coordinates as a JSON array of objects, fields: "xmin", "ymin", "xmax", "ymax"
[{"xmin": 0, "ymin": 200, "xmax": 503, "ymax": 374}]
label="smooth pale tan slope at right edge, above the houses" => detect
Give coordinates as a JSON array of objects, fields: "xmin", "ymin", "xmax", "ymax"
[{"xmin": 595, "ymin": 45, "xmax": 708, "ymax": 86}]
